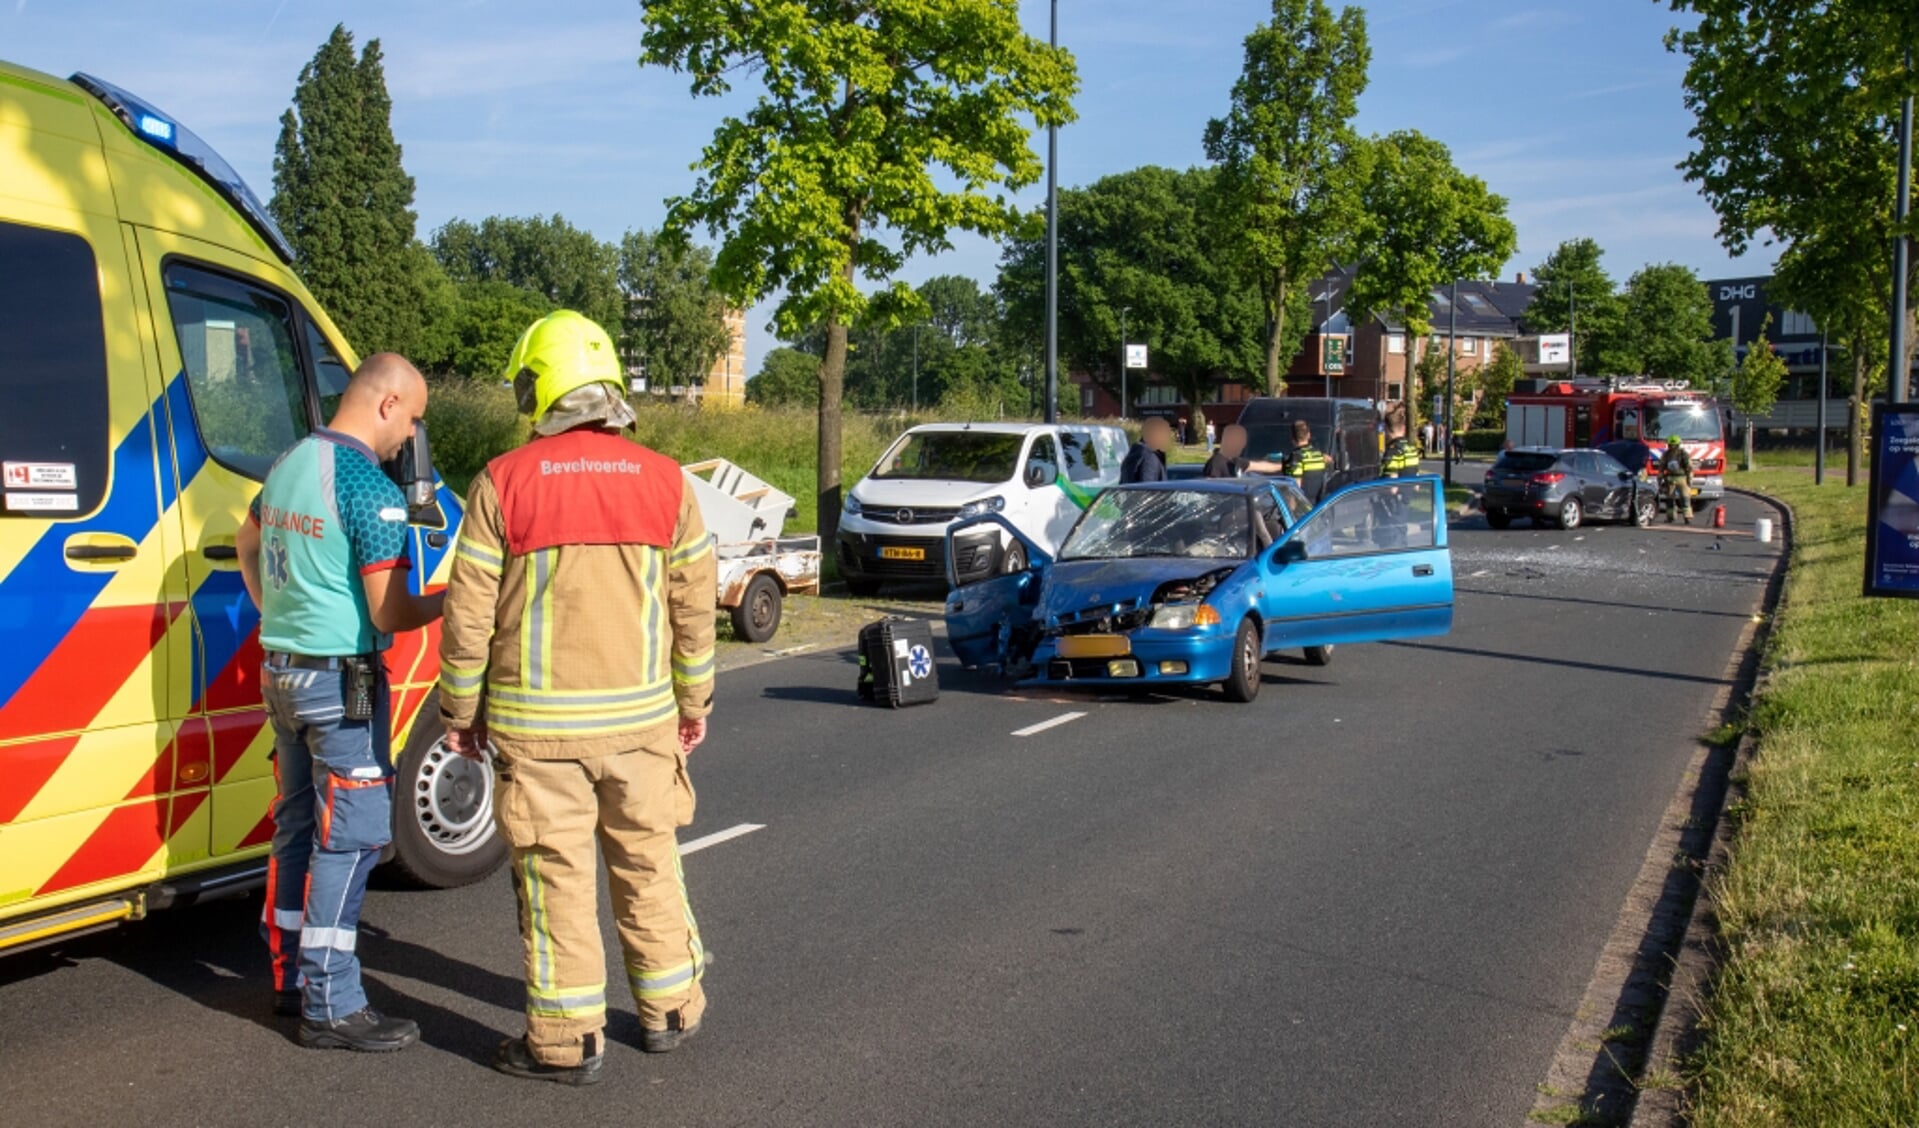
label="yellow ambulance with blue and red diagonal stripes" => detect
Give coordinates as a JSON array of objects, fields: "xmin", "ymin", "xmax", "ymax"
[{"xmin": 0, "ymin": 63, "xmax": 505, "ymax": 952}]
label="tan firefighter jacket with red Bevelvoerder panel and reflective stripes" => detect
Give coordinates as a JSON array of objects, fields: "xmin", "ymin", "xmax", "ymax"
[{"xmin": 439, "ymin": 430, "xmax": 718, "ymax": 760}]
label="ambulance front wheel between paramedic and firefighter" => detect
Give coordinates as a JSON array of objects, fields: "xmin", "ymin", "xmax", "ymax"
[{"xmin": 391, "ymin": 693, "xmax": 507, "ymax": 888}]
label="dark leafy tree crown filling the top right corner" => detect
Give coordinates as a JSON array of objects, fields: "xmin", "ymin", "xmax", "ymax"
[{"xmin": 1666, "ymin": 0, "xmax": 1919, "ymax": 404}]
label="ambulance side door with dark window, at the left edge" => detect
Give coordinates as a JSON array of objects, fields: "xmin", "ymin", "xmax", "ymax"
[{"xmin": 0, "ymin": 213, "xmax": 189, "ymax": 917}]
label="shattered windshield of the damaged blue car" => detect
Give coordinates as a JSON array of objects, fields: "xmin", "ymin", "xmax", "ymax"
[{"xmin": 1059, "ymin": 489, "xmax": 1253, "ymax": 560}]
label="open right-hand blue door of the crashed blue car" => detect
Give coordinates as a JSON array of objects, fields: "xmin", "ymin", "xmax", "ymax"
[{"xmin": 1259, "ymin": 478, "xmax": 1453, "ymax": 652}]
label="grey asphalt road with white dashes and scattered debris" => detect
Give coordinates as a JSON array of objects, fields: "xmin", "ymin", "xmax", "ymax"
[{"xmin": 0, "ymin": 471, "xmax": 1779, "ymax": 1126}]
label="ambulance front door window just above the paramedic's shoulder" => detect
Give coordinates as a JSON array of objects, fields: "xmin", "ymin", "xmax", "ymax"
[{"xmin": 163, "ymin": 263, "xmax": 311, "ymax": 480}]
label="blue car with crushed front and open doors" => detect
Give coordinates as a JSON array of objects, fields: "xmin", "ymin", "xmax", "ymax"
[{"xmin": 946, "ymin": 478, "xmax": 1453, "ymax": 702}]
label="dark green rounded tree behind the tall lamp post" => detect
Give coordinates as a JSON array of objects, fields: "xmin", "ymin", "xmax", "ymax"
[{"xmin": 1000, "ymin": 167, "xmax": 1266, "ymax": 427}]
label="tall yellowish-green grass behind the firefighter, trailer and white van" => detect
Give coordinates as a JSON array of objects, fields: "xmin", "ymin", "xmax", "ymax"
[{"xmin": 426, "ymin": 380, "xmax": 1120, "ymax": 531}]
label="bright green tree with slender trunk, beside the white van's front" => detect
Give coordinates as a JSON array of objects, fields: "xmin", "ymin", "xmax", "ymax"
[{"xmin": 641, "ymin": 0, "xmax": 1078, "ymax": 539}]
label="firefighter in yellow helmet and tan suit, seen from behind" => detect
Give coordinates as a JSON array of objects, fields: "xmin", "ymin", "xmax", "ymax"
[{"xmin": 439, "ymin": 311, "xmax": 718, "ymax": 1086}]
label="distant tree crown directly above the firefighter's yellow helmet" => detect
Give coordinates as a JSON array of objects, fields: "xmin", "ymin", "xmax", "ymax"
[{"xmin": 434, "ymin": 215, "xmax": 626, "ymax": 332}]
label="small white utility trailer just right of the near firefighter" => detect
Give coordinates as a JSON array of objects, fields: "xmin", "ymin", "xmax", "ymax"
[{"xmin": 685, "ymin": 458, "xmax": 819, "ymax": 643}]
